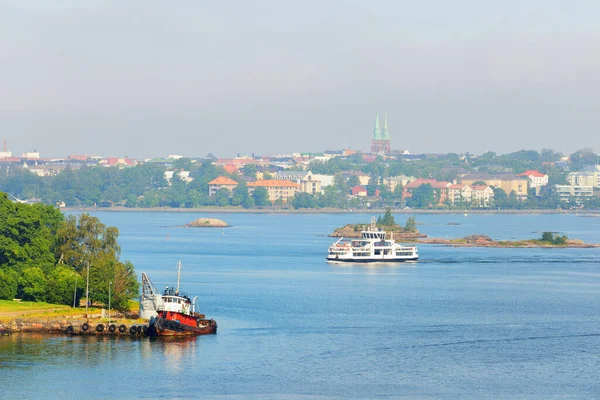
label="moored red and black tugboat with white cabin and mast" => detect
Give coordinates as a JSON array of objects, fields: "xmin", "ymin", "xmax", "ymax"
[{"xmin": 140, "ymin": 261, "xmax": 217, "ymax": 336}]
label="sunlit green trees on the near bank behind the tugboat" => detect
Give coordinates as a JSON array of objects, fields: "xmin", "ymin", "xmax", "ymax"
[{"xmin": 0, "ymin": 193, "xmax": 139, "ymax": 310}]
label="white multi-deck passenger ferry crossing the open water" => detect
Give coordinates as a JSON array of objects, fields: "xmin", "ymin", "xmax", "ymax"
[{"xmin": 327, "ymin": 219, "xmax": 419, "ymax": 263}]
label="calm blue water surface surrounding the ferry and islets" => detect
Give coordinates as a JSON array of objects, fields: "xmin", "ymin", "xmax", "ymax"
[{"xmin": 0, "ymin": 212, "xmax": 600, "ymax": 399}]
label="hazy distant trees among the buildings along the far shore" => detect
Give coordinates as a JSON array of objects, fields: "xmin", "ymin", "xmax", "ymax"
[{"xmin": 0, "ymin": 149, "xmax": 600, "ymax": 209}]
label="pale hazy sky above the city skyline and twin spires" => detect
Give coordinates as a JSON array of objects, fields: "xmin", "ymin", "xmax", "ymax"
[{"xmin": 0, "ymin": 0, "xmax": 600, "ymax": 158}]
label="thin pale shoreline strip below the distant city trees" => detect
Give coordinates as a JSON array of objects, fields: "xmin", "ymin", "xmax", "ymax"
[{"xmin": 60, "ymin": 207, "xmax": 600, "ymax": 217}]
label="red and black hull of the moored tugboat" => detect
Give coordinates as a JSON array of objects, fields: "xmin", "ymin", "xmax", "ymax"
[{"xmin": 146, "ymin": 311, "xmax": 217, "ymax": 336}]
